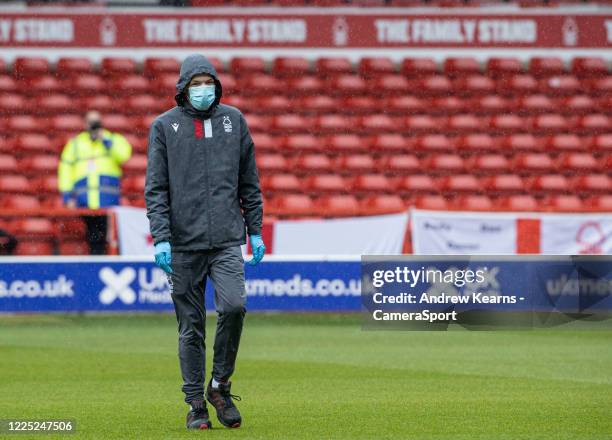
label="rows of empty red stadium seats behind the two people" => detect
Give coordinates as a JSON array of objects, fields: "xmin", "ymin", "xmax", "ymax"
[{"xmin": 0, "ymin": 57, "xmax": 612, "ymax": 253}]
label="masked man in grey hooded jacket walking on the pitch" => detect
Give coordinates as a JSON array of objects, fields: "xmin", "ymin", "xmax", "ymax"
[{"xmin": 145, "ymin": 55, "xmax": 265, "ymax": 429}]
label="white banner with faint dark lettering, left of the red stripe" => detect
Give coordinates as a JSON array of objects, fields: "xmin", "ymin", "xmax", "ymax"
[{"xmin": 411, "ymin": 209, "xmax": 518, "ymax": 255}]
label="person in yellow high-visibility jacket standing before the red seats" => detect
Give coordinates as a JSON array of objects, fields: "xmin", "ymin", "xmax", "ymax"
[{"xmin": 58, "ymin": 110, "xmax": 132, "ymax": 254}]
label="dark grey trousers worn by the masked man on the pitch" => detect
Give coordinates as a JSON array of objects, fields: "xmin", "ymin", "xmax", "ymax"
[{"xmin": 169, "ymin": 246, "xmax": 246, "ymax": 403}]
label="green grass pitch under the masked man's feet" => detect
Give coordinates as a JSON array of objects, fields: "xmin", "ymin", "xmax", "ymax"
[{"xmin": 0, "ymin": 313, "xmax": 612, "ymax": 440}]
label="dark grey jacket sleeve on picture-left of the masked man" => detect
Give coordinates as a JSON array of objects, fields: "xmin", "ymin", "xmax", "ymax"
[{"xmin": 145, "ymin": 121, "xmax": 170, "ymax": 244}]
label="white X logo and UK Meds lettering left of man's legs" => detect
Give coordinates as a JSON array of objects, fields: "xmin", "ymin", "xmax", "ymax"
[{"xmin": 98, "ymin": 267, "xmax": 172, "ymax": 305}]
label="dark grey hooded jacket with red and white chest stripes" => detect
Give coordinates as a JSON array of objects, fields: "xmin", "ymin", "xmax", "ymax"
[{"xmin": 145, "ymin": 55, "xmax": 263, "ymax": 251}]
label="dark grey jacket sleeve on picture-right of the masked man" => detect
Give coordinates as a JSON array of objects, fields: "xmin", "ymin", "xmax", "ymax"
[{"xmin": 238, "ymin": 115, "xmax": 263, "ymax": 235}]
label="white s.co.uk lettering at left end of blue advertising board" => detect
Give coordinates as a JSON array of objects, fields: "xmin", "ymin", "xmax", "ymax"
[{"xmin": 0, "ymin": 275, "xmax": 74, "ymax": 298}]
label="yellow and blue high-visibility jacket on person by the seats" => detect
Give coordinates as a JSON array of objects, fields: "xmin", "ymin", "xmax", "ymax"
[{"xmin": 57, "ymin": 130, "xmax": 132, "ymax": 209}]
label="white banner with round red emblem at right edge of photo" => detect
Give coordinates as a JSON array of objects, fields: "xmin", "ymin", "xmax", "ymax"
[{"xmin": 540, "ymin": 214, "xmax": 612, "ymax": 255}]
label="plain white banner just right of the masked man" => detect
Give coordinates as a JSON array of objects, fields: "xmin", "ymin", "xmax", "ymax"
[{"xmin": 273, "ymin": 212, "xmax": 408, "ymax": 255}]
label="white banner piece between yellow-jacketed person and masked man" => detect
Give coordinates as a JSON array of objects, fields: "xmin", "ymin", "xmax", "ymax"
[{"xmin": 113, "ymin": 206, "xmax": 155, "ymax": 255}]
